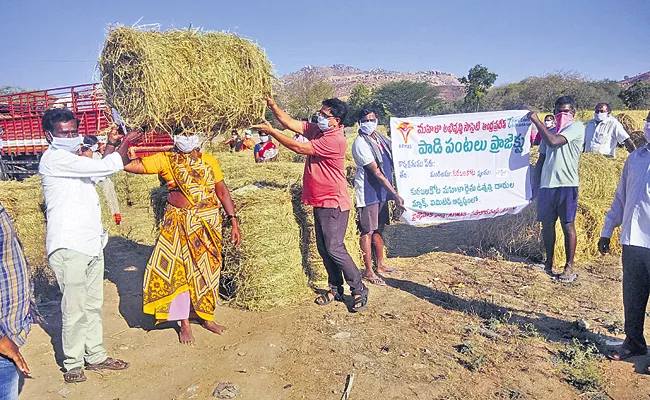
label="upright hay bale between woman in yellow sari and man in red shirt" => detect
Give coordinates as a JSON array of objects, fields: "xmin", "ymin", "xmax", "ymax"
[{"xmin": 222, "ymin": 187, "xmax": 311, "ymax": 310}]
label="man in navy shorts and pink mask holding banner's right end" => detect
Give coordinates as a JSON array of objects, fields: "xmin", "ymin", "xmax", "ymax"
[{"xmin": 528, "ymin": 96, "xmax": 585, "ymax": 283}]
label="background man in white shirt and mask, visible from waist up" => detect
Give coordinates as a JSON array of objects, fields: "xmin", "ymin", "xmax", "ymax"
[{"xmin": 585, "ymin": 103, "xmax": 636, "ymax": 157}]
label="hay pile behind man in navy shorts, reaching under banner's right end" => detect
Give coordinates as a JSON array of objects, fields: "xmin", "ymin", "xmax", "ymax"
[{"xmin": 469, "ymin": 149, "xmax": 627, "ymax": 265}]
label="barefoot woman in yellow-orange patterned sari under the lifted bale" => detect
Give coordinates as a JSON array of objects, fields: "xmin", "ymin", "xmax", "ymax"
[{"xmin": 124, "ymin": 129, "xmax": 241, "ymax": 344}]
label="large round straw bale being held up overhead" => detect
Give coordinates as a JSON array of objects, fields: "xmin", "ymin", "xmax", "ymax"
[{"xmin": 99, "ymin": 27, "xmax": 272, "ymax": 136}]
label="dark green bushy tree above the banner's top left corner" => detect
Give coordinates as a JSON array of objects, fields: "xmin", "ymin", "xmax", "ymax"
[{"xmin": 372, "ymin": 81, "xmax": 444, "ymax": 118}]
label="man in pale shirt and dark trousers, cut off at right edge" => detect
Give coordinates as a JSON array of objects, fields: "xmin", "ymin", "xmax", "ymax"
[{"xmin": 598, "ymin": 109, "xmax": 650, "ymax": 360}]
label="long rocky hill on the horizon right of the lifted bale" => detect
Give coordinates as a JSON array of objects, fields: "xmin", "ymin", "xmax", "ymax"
[{"xmin": 281, "ymin": 64, "xmax": 463, "ymax": 100}]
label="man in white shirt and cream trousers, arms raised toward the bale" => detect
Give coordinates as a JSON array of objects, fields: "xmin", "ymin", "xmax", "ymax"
[{"xmin": 38, "ymin": 108, "xmax": 142, "ymax": 383}]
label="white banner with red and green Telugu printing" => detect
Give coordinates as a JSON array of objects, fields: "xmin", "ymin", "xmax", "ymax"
[{"xmin": 390, "ymin": 111, "xmax": 532, "ymax": 225}]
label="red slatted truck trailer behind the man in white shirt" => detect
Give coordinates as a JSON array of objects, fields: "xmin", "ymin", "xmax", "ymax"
[{"xmin": 0, "ymin": 83, "xmax": 174, "ymax": 179}]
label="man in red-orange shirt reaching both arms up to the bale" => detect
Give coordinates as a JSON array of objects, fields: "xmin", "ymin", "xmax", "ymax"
[{"xmin": 253, "ymin": 97, "xmax": 368, "ymax": 312}]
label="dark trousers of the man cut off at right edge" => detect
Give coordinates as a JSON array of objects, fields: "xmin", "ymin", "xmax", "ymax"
[{"xmin": 623, "ymin": 246, "xmax": 650, "ymax": 352}]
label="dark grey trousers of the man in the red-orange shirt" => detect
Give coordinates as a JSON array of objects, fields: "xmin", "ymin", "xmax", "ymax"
[{"xmin": 314, "ymin": 207, "xmax": 367, "ymax": 295}]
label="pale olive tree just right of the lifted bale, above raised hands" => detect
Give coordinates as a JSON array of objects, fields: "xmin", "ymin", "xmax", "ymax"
[{"xmin": 278, "ymin": 73, "xmax": 334, "ymax": 119}]
